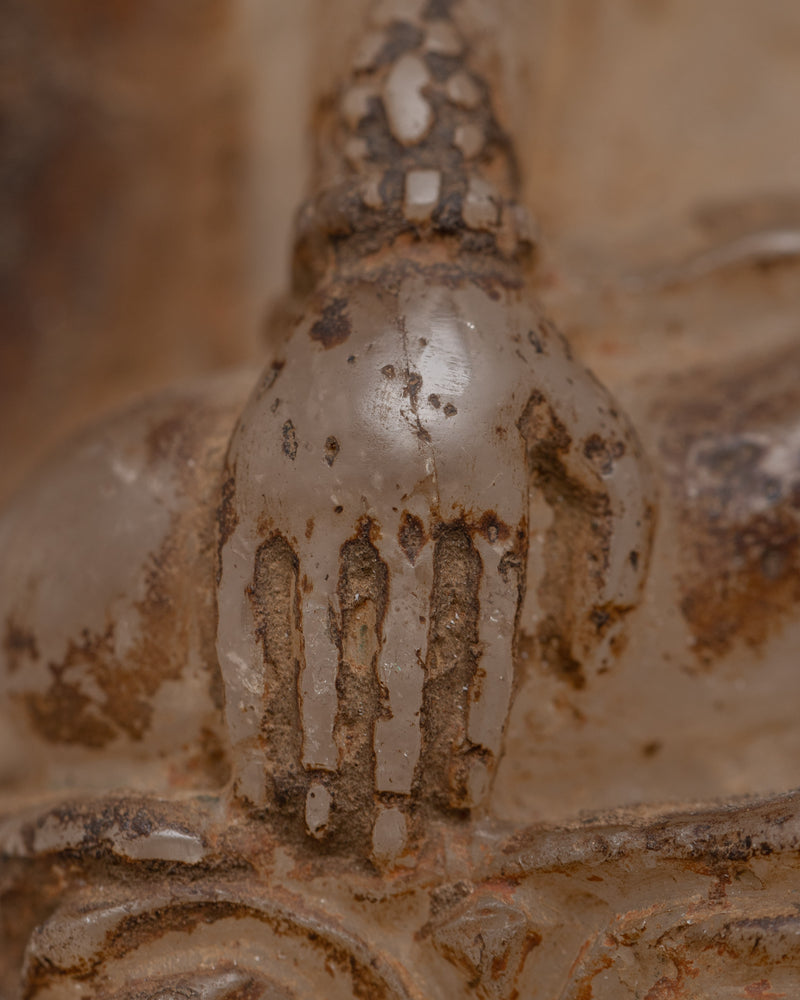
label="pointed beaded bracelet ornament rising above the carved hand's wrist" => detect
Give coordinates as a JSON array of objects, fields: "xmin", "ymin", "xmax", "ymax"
[{"xmin": 294, "ymin": 0, "xmax": 534, "ymax": 293}]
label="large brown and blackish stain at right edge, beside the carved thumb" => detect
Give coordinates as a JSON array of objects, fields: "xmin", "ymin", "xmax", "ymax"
[{"xmin": 655, "ymin": 347, "xmax": 800, "ymax": 664}]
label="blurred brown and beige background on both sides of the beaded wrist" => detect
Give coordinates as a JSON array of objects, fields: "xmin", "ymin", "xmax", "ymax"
[{"xmin": 0, "ymin": 0, "xmax": 800, "ymax": 500}]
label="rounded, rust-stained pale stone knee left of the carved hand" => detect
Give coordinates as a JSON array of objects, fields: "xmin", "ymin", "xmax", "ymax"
[{"xmin": 0, "ymin": 370, "xmax": 256, "ymax": 796}]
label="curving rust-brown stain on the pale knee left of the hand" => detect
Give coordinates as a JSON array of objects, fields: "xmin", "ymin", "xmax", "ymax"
[{"xmin": 11, "ymin": 388, "xmax": 236, "ymax": 752}]
